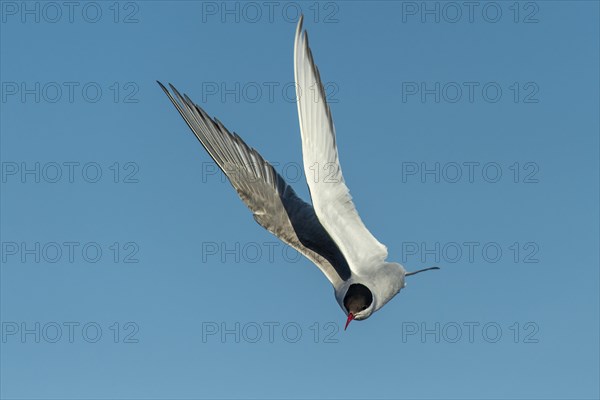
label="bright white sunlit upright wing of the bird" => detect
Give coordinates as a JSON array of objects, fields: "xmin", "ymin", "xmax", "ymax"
[{"xmin": 294, "ymin": 14, "xmax": 387, "ymax": 274}]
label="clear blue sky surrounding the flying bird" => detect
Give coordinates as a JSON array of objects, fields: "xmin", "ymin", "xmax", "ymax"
[{"xmin": 0, "ymin": 1, "xmax": 600, "ymax": 399}]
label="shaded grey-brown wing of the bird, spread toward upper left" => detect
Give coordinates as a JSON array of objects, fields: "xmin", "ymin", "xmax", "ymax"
[{"xmin": 158, "ymin": 82, "xmax": 350, "ymax": 287}]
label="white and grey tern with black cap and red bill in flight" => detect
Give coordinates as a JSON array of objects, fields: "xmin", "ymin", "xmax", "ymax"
[{"xmin": 158, "ymin": 16, "xmax": 439, "ymax": 329}]
